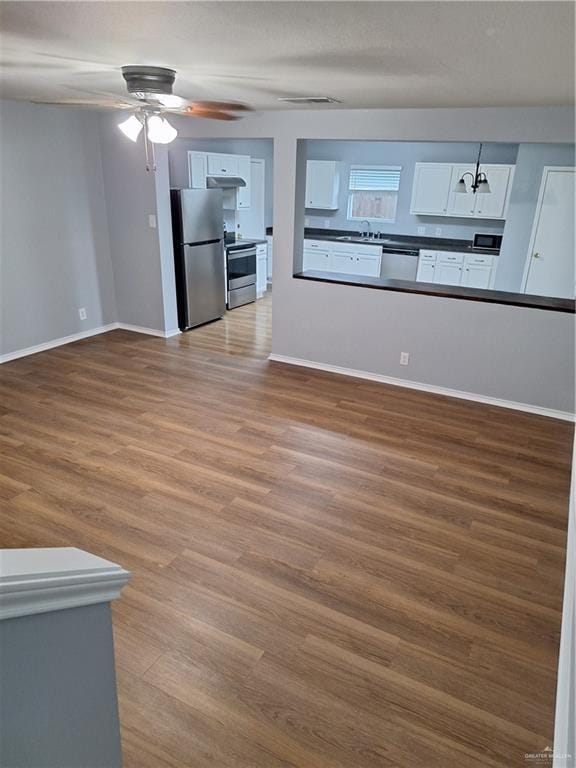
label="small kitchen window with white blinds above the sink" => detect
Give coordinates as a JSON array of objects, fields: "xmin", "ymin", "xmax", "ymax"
[{"xmin": 348, "ymin": 165, "xmax": 402, "ymax": 221}]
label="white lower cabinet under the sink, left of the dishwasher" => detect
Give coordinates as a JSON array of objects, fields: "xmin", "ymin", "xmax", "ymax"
[{"xmin": 302, "ymin": 240, "xmax": 382, "ymax": 277}]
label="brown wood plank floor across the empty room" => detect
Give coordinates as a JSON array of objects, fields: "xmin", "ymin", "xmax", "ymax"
[{"xmin": 0, "ymin": 292, "xmax": 572, "ymax": 768}]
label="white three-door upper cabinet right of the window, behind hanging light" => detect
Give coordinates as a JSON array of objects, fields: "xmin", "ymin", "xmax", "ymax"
[{"xmin": 410, "ymin": 163, "xmax": 514, "ymax": 219}]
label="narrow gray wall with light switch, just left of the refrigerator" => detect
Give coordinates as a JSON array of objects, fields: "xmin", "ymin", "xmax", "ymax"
[{"xmin": 100, "ymin": 109, "xmax": 178, "ymax": 331}]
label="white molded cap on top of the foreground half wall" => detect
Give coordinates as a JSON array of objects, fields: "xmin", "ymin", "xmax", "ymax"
[{"xmin": 0, "ymin": 547, "xmax": 130, "ymax": 619}]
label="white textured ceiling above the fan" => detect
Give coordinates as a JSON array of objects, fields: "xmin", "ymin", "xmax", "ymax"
[{"xmin": 0, "ymin": 0, "xmax": 574, "ymax": 109}]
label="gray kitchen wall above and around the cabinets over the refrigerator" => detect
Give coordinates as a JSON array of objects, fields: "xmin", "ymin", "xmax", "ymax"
[{"xmin": 168, "ymin": 137, "xmax": 274, "ymax": 227}]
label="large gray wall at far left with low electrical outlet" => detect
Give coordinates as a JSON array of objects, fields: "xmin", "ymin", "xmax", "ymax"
[{"xmin": 0, "ymin": 101, "xmax": 116, "ymax": 354}]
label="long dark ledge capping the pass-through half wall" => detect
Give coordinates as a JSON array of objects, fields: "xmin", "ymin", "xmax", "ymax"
[{"xmin": 293, "ymin": 270, "xmax": 576, "ymax": 314}]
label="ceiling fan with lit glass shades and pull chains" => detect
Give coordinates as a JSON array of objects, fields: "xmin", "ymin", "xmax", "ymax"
[{"xmin": 37, "ymin": 65, "xmax": 251, "ymax": 171}]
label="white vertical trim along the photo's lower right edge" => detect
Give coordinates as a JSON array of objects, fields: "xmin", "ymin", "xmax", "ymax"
[{"xmin": 553, "ymin": 441, "xmax": 576, "ymax": 768}]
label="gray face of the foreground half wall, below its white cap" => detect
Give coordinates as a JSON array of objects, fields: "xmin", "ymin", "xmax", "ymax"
[{"xmin": 0, "ymin": 603, "xmax": 122, "ymax": 768}]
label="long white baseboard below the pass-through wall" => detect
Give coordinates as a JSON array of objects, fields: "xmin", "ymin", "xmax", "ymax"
[{"xmin": 268, "ymin": 353, "xmax": 575, "ymax": 421}]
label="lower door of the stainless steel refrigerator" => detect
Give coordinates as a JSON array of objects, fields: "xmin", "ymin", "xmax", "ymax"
[{"xmin": 184, "ymin": 240, "xmax": 226, "ymax": 328}]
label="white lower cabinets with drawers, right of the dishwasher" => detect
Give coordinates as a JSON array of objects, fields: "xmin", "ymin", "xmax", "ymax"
[{"xmin": 416, "ymin": 250, "xmax": 496, "ymax": 288}]
